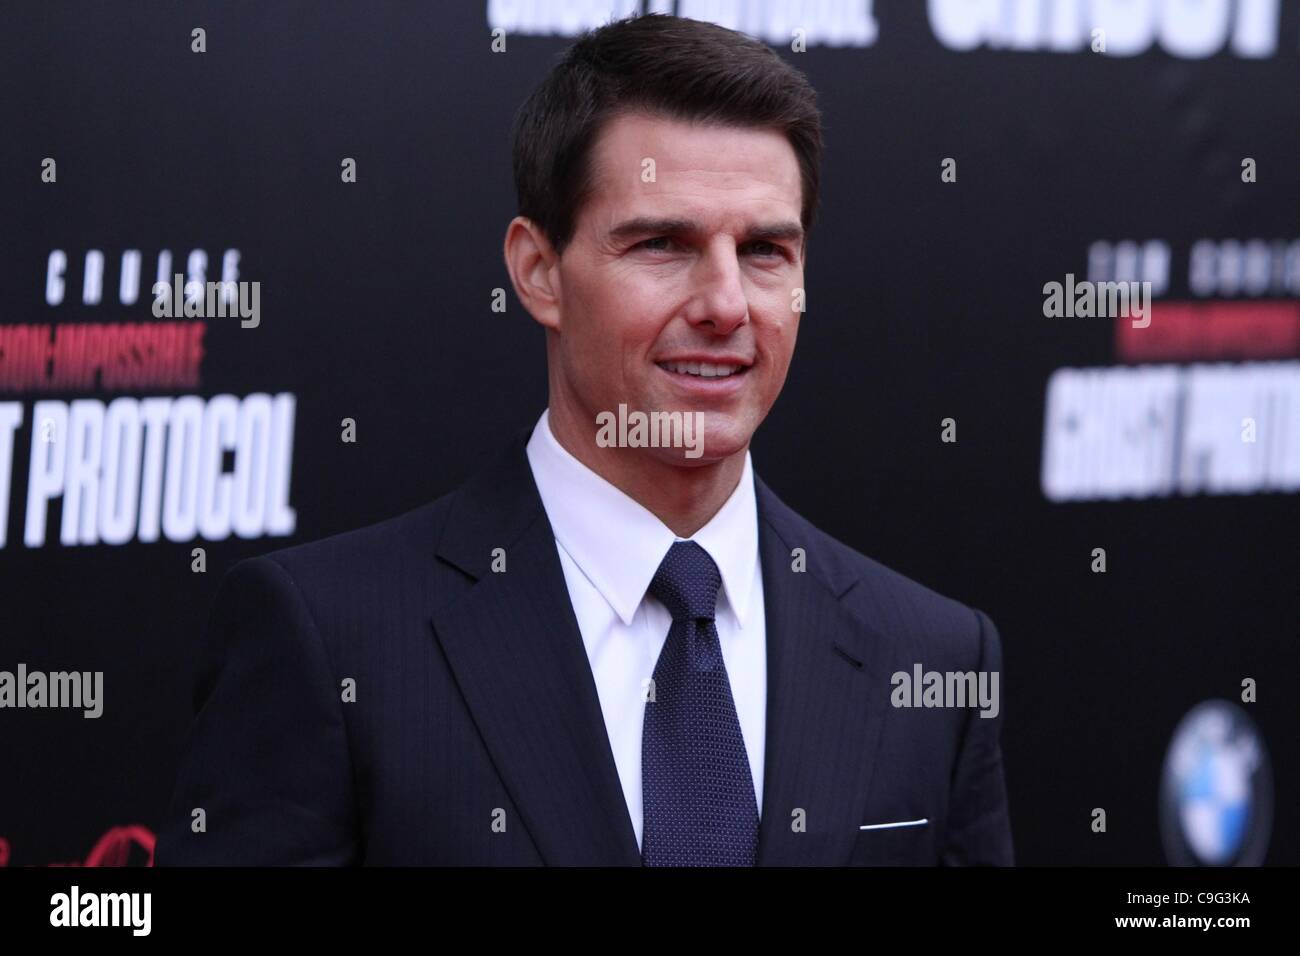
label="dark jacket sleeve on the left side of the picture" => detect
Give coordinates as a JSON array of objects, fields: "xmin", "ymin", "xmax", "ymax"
[{"xmin": 153, "ymin": 557, "xmax": 361, "ymax": 866}]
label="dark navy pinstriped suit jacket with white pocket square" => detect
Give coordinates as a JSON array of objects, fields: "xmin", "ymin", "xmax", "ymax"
[{"xmin": 155, "ymin": 436, "xmax": 1013, "ymax": 866}]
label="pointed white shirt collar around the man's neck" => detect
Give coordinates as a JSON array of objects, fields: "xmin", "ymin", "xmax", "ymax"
[{"xmin": 527, "ymin": 411, "xmax": 758, "ymax": 627}]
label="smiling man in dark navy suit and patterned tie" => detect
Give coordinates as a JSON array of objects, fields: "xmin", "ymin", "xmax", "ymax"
[{"xmin": 156, "ymin": 16, "xmax": 1013, "ymax": 865}]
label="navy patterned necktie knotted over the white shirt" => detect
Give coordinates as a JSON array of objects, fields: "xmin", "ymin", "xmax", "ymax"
[{"xmin": 641, "ymin": 541, "xmax": 758, "ymax": 866}]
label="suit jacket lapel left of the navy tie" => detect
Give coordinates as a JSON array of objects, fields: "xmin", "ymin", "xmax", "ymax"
[{"xmin": 433, "ymin": 440, "xmax": 641, "ymax": 866}]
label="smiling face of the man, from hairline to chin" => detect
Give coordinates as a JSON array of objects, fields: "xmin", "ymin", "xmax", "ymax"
[{"xmin": 551, "ymin": 114, "xmax": 803, "ymax": 464}]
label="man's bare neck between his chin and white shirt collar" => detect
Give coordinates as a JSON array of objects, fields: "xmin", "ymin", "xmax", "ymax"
[{"xmin": 547, "ymin": 405, "xmax": 746, "ymax": 537}]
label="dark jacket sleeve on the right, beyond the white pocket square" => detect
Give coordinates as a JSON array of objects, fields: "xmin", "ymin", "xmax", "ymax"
[{"xmin": 941, "ymin": 610, "xmax": 1015, "ymax": 866}]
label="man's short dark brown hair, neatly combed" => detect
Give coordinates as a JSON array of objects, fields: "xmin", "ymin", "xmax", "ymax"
[{"xmin": 511, "ymin": 13, "xmax": 822, "ymax": 255}]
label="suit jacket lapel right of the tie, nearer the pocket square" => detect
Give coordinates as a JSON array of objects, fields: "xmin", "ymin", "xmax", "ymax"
[{"xmin": 755, "ymin": 477, "xmax": 893, "ymax": 866}]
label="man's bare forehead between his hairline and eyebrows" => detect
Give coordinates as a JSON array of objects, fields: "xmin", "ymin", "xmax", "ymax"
[{"xmin": 580, "ymin": 113, "xmax": 802, "ymax": 229}]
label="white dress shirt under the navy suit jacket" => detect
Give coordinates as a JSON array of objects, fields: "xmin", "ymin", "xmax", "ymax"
[{"xmin": 528, "ymin": 412, "xmax": 767, "ymax": 847}]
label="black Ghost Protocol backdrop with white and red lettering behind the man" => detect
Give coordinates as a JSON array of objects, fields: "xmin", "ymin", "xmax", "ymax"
[{"xmin": 0, "ymin": 0, "xmax": 1300, "ymax": 865}]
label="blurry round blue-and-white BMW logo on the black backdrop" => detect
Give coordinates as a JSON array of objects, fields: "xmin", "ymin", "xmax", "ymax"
[{"xmin": 1160, "ymin": 700, "xmax": 1273, "ymax": 866}]
